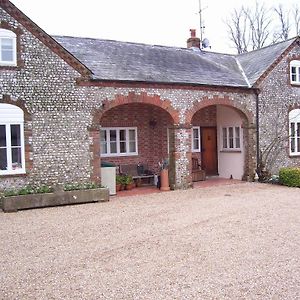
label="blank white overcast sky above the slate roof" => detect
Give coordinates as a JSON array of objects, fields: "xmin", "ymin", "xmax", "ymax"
[{"xmin": 11, "ymin": 0, "xmax": 299, "ymax": 53}]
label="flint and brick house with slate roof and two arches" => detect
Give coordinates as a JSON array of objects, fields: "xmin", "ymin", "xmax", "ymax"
[{"xmin": 0, "ymin": 0, "xmax": 300, "ymax": 189}]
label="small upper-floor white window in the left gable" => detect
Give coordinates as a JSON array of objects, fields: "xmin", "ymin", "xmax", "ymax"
[{"xmin": 0, "ymin": 28, "xmax": 17, "ymax": 66}]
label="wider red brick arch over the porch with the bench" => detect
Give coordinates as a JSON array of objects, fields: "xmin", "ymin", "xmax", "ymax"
[{"xmin": 92, "ymin": 92, "xmax": 179, "ymax": 125}]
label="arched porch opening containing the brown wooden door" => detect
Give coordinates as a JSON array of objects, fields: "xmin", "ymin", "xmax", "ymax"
[{"xmin": 191, "ymin": 104, "xmax": 253, "ymax": 180}]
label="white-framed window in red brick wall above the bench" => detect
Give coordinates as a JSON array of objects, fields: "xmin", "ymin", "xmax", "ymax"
[{"xmin": 100, "ymin": 127, "xmax": 138, "ymax": 157}]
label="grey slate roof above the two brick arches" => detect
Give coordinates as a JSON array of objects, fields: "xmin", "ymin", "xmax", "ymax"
[{"xmin": 53, "ymin": 36, "xmax": 295, "ymax": 87}]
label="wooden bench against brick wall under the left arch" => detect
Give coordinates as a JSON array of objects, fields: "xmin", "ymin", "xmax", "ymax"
[{"xmin": 119, "ymin": 164, "xmax": 154, "ymax": 186}]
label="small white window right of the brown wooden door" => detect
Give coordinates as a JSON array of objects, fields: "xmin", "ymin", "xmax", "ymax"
[{"xmin": 221, "ymin": 126, "xmax": 241, "ymax": 150}]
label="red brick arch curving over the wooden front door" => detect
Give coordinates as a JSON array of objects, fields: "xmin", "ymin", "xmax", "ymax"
[{"xmin": 186, "ymin": 96, "xmax": 254, "ymax": 124}]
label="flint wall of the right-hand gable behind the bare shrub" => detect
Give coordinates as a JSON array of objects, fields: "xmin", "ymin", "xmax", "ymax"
[{"xmin": 259, "ymin": 46, "xmax": 300, "ymax": 174}]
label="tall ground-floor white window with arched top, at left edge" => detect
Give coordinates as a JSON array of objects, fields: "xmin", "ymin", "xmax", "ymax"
[{"xmin": 0, "ymin": 104, "xmax": 25, "ymax": 175}]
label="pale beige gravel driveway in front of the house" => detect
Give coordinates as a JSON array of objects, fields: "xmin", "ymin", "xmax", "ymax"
[{"xmin": 0, "ymin": 183, "xmax": 300, "ymax": 300}]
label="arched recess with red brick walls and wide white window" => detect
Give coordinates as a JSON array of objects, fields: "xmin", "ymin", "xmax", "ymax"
[{"xmin": 99, "ymin": 103, "xmax": 174, "ymax": 173}]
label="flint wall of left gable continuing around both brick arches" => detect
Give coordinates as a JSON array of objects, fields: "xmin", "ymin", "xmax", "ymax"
[{"xmin": 0, "ymin": 5, "xmax": 255, "ymax": 189}]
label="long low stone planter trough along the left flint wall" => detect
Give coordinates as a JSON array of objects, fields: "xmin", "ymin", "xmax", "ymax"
[{"xmin": 1, "ymin": 188, "xmax": 109, "ymax": 212}]
